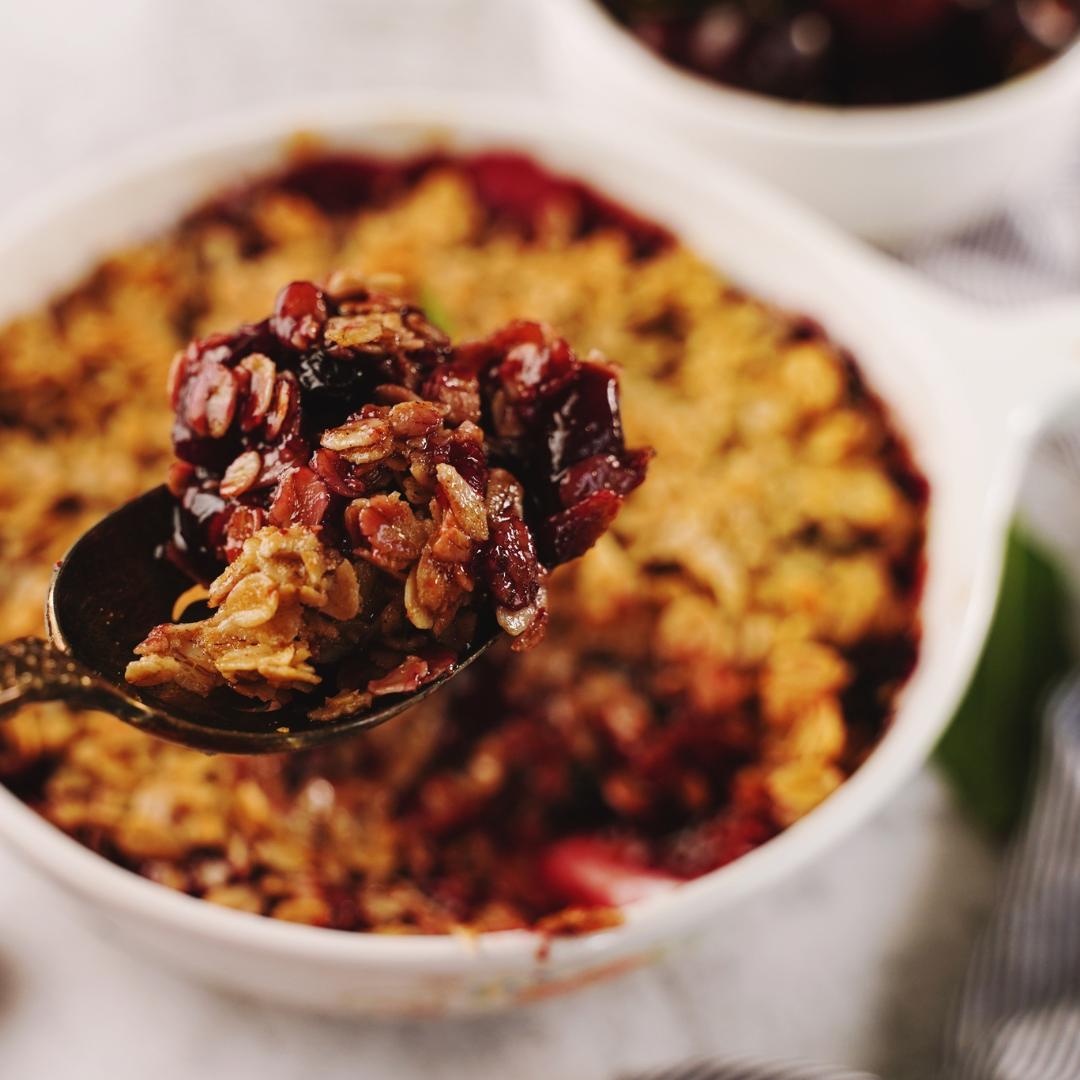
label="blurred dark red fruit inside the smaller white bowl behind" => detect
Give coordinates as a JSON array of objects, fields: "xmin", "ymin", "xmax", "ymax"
[{"xmin": 600, "ymin": 0, "xmax": 1080, "ymax": 106}]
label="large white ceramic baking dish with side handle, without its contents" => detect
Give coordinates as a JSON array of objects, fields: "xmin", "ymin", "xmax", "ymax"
[{"xmin": 0, "ymin": 95, "xmax": 1080, "ymax": 1015}]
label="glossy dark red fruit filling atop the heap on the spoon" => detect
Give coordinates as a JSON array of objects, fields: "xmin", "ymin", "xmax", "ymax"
[{"xmin": 170, "ymin": 275, "xmax": 651, "ymax": 630}]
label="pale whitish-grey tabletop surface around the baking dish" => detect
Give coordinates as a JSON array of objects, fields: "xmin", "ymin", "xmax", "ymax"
[{"xmin": 0, "ymin": 0, "xmax": 1015, "ymax": 1080}]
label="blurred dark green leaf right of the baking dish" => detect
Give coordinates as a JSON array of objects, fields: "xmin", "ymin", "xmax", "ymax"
[{"xmin": 935, "ymin": 526, "xmax": 1070, "ymax": 835}]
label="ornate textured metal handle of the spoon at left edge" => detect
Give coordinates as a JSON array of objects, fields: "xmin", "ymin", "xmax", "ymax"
[{"xmin": 0, "ymin": 637, "xmax": 141, "ymax": 716}]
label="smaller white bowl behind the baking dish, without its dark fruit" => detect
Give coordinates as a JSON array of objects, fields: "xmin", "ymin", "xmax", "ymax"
[{"xmin": 534, "ymin": 0, "xmax": 1080, "ymax": 245}]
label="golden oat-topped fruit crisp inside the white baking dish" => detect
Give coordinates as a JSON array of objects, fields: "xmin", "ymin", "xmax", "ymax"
[{"xmin": 0, "ymin": 152, "xmax": 929, "ymax": 933}]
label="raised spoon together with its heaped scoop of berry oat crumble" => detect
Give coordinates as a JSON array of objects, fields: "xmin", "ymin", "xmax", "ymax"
[{"xmin": 0, "ymin": 273, "xmax": 651, "ymax": 753}]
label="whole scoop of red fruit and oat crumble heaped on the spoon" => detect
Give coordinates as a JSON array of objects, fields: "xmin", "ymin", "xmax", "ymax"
[{"xmin": 127, "ymin": 273, "xmax": 651, "ymax": 719}]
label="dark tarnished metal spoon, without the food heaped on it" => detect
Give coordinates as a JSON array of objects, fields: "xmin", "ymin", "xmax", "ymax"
[{"xmin": 0, "ymin": 485, "xmax": 499, "ymax": 754}]
